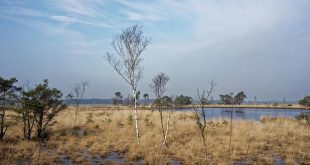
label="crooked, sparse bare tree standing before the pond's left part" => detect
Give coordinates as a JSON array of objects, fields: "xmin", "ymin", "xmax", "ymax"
[{"xmin": 193, "ymin": 81, "xmax": 216, "ymax": 161}]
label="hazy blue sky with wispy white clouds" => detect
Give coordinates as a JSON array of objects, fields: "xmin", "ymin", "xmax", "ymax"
[{"xmin": 0, "ymin": 0, "xmax": 310, "ymax": 101}]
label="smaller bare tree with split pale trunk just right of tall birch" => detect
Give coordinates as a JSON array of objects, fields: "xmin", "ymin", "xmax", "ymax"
[{"xmin": 149, "ymin": 73, "xmax": 170, "ymax": 146}]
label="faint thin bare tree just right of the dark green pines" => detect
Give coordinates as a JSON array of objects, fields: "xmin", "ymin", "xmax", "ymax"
[{"xmin": 67, "ymin": 81, "xmax": 89, "ymax": 127}]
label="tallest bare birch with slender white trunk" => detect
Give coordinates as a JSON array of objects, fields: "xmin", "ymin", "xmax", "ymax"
[{"xmin": 105, "ymin": 25, "xmax": 151, "ymax": 144}]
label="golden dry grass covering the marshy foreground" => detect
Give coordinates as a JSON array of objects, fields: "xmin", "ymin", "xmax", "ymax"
[{"xmin": 0, "ymin": 107, "xmax": 310, "ymax": 164}]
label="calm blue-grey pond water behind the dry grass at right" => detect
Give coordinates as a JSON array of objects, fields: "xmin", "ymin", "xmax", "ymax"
[{"xmin": 177, "ymin": 108, "xmax": 310, "ymax": 121}]
